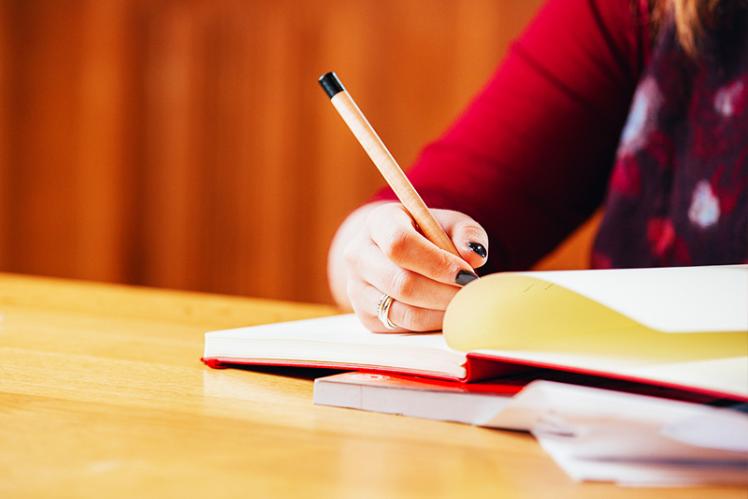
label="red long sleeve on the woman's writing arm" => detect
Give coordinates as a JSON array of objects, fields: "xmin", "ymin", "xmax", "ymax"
[{"xmin": 374, "ymin": 0, "xmax": 644, "ymax": 271}]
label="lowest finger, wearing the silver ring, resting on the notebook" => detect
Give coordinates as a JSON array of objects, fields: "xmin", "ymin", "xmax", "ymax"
[{"xmin": 348, "ymin": 280, "xmax": 444, "ymax": 333}]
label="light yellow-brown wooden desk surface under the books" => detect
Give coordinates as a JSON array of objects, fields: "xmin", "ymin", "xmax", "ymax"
[{"xmin": 0, "ymin": 274, "xmax": 746, "ymax": 499}]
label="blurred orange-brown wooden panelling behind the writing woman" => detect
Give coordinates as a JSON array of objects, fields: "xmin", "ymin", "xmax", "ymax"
[{"xmin": 0, "ymin": 0, "xmax": 596, "ymax": 302}]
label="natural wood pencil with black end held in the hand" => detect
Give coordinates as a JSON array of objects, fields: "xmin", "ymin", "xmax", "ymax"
[{"xmin": 319, "ymin": 71, "xmax": 460, "ymax": 256}]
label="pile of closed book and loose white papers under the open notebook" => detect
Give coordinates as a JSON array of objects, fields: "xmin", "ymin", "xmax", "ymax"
[{"xmin": 314, "ymin": 373, "xmax": 748, "ymax": 486}]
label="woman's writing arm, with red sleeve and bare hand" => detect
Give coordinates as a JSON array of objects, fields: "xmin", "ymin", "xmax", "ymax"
[{"xmin": 328, "ymin": 0, "xmax": 643, "ymax": 330}]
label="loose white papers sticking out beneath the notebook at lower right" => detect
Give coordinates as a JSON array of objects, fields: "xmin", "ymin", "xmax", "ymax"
[{"xmin": 484, "ymin": 381, "xmax": 748, "ymax": 486}]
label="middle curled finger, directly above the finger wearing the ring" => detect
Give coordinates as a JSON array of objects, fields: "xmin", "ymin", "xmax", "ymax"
[{"xmin": 349, "ymin": 242, "xmax": 459, "ymax": 310}]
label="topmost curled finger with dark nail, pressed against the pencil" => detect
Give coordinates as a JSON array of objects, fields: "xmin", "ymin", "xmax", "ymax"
[{"xmin": 366, "ymin": 204, "xmax": 474, "ymax": 286}]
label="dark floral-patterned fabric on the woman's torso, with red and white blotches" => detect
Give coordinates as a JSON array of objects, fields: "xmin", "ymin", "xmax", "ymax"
[{"xmin": 592, "ymin": 19, "xmax": 748, "ymax": 268}]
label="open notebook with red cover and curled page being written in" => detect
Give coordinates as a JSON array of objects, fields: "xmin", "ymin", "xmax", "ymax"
[{"xmin": 203, "ymin": 265, "xmax": 748, "ymax": 401}]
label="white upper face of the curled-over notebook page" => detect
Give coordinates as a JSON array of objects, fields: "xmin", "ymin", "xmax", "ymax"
[{"xmin": 523, "ymin": 265, "xmax": 748, "ymax": 333}]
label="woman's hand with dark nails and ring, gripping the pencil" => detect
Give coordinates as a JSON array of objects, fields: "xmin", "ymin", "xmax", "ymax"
[{"xmin": 330, "ymin": 203, "xmax": 488, "ymax": 332}]
